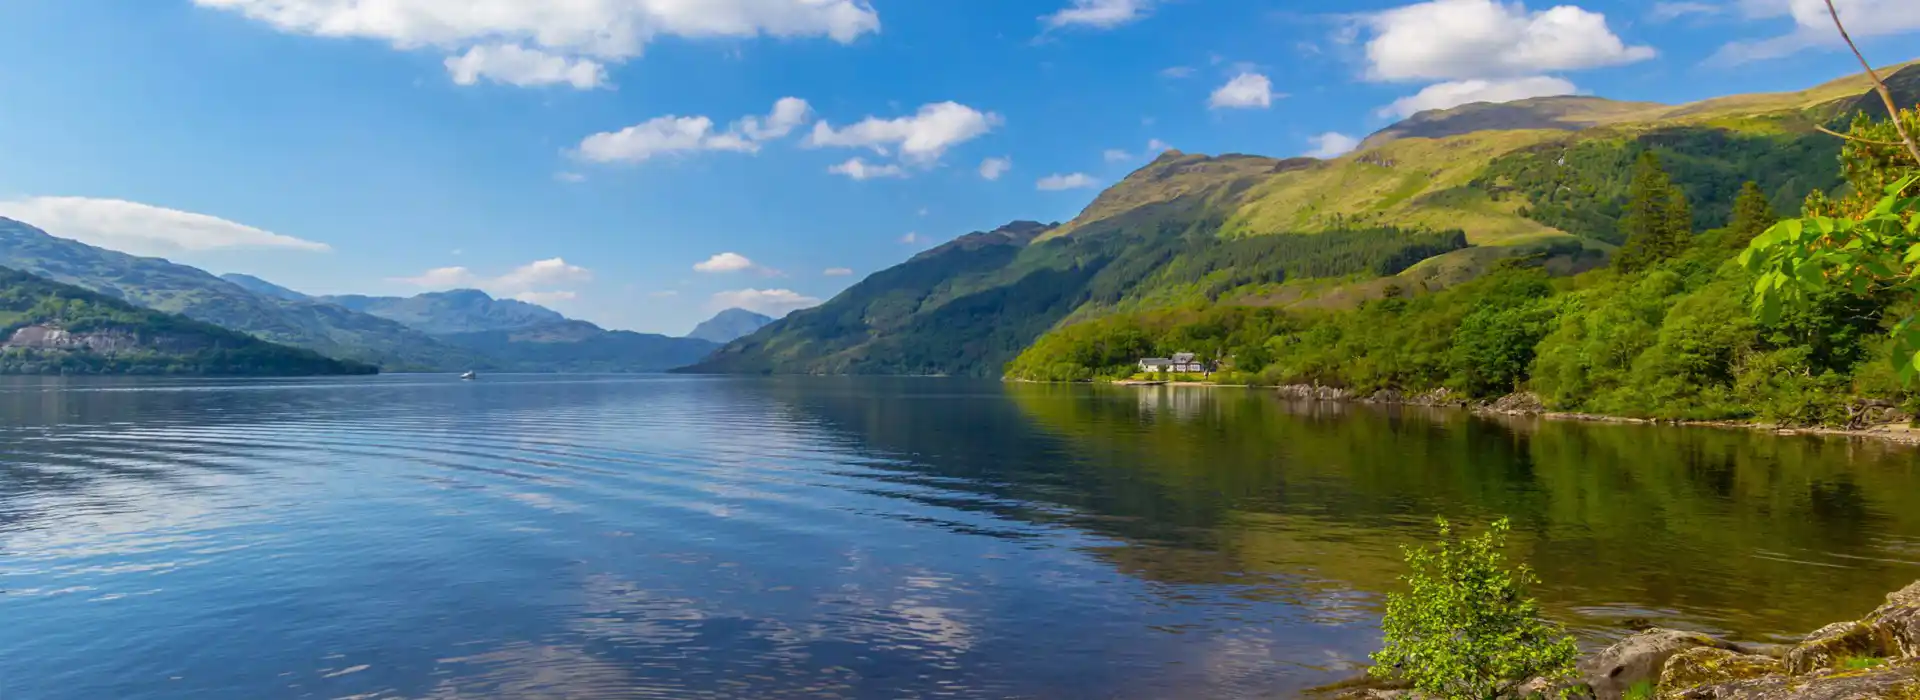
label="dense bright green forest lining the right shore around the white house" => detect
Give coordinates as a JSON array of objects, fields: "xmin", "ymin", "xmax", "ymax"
[{"xmin": 1008, "ymin": 109, "xmax": 1914, "ymax": 424}]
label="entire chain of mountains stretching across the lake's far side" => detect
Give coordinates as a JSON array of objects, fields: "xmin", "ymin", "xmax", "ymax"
[{"xmin": 11, "ymin": 65, "xmax": 1920, "ymax": 376}]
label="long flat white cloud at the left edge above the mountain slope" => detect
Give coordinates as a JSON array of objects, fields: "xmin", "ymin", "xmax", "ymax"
[{"xmin": 0, "ymin": 198, "xmax": 332, "ymax": 255}]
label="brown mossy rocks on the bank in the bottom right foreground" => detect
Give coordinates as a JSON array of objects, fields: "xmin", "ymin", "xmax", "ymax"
[{"xmin": 1313, "ymin": 581, "xmax": 1920, "ymax": 700}]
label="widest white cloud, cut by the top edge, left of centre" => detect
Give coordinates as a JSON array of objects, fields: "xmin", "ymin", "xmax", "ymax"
[{"xmin": 194, "ymin": 0, "xmax": 879, "ymax": 88}]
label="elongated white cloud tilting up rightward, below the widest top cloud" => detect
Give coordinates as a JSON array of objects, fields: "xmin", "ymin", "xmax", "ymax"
[{"xmin": 574, "ymin": 98, "xmax": 812, "ymax": 163}]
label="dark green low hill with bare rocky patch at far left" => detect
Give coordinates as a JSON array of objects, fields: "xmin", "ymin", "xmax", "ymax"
[{"xmin": 0, "ymin": 268, "xmax": 376, "ymax": 376}]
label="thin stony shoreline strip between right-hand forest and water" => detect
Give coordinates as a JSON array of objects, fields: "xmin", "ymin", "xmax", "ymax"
[{"xmin": 1044, "ymin": 380, "xmax": 1920, "ymax": 447}]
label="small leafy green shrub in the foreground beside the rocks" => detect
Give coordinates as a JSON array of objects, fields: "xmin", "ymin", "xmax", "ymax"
[{"xmin": 1371, "ymin": 518, "xmax": 1578, "ymax": 700}]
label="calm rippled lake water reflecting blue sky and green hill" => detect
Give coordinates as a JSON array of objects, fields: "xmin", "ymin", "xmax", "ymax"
[{"xmin": 0, "ymin": 376, "xmax": 1920, "ymax": 700}]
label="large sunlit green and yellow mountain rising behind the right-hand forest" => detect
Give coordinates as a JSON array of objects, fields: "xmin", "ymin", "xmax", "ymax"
[{"xmin": 687, "ymin": 58, "xmax": 1920, "ymax": 376}]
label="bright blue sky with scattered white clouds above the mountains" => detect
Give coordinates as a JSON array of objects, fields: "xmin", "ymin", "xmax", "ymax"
[{"xmin": 0, "ymin": 0, "xmax": 1920, "ymax": 334}]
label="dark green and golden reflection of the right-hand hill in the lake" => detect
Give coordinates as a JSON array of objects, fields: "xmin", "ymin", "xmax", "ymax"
[{"xmin": 748, "ymin": 382, "xmax": 1920, "ymax": 637}]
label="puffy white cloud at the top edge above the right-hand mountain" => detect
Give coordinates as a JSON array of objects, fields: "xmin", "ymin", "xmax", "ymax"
[{"xmin": 1361, "ymin": 0, "xmax": 1658, "ymax": 81}]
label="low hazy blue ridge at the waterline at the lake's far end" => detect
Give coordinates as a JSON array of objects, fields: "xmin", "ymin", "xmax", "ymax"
[{"xmin": 436, "ymin": 320, "xmax": 720, "ymax": 372}]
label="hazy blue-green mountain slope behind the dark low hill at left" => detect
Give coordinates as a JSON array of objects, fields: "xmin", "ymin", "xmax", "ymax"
[{"xmin": 0, "ymin": 217, "xmax": 486, "ymax": 370}]
